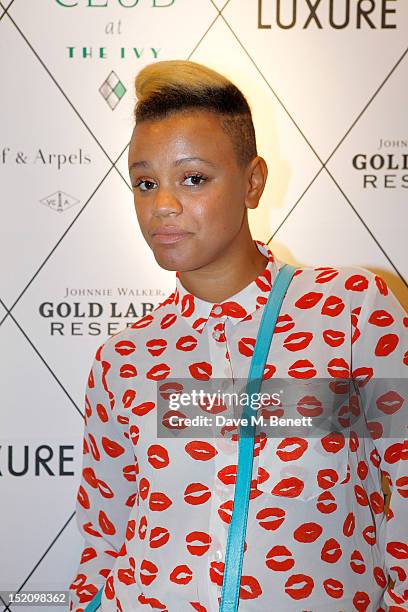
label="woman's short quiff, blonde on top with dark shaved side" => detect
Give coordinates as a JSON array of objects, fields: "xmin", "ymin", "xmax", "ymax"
[{"xmin": 134, "ymin": 60, "xmax": 257, "ymax": 166}]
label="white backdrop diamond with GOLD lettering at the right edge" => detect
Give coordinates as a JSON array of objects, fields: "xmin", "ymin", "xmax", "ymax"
[{"xmin": 327, "ymin": 51, "xmax": 408, "ymax": 284}]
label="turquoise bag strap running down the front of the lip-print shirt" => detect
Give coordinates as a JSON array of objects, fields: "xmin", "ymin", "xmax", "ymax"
[{"xmin": 220, "ymin": 264, "xmax": 296, "ymax": 612}]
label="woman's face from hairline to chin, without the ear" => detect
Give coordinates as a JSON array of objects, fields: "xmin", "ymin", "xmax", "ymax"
[{"xmin": 129, "ymin": 111, "xmax": 255, "ymax": 271}]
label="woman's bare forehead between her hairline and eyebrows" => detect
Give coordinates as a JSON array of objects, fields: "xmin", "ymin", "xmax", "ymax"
[{"xmin": 129, "ymin": 110, "xmax": 232, "ymax": 158}]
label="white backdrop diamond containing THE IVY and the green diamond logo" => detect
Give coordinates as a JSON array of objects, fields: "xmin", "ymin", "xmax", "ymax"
[{"xmin": 6, "ymin": 0, "xmax": 222, "ymax": 159}]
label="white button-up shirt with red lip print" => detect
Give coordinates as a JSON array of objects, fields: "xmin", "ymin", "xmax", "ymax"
[{"xmin": 69, "ymin": 240, "xmax": 408, "ymax": 612}]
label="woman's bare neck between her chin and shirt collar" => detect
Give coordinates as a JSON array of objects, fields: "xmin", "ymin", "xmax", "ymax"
[{"xmin": 179, "ymin": 232, "xmax": 268, "ymax": 303}]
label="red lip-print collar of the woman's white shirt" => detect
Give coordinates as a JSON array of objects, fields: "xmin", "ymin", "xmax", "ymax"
[{"xmin": 172, "ymin": 240, "xmax": 278, "ymax": 333}]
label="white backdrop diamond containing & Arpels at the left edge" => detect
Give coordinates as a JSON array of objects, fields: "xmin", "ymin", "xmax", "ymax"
[{"xmin": 0, "ymin": 15, "xmax": 111, "ymax": 306}]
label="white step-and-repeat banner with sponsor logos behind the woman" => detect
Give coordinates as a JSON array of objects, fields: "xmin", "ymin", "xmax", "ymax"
[{"xmin": 0, "ymin": 0, "xmax": 408, "ymax": 610}]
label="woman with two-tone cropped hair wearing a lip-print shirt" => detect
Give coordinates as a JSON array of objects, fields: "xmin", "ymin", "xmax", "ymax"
[{"xmin": 70, "ymin": 61, "xmax": 408, "ymax": 612}]
